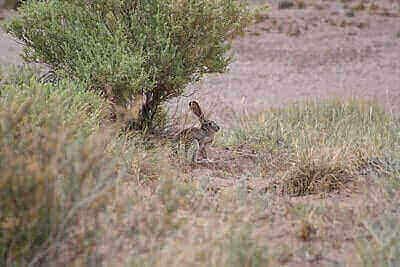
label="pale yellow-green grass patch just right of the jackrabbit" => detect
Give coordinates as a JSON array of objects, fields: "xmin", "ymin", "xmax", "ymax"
[{"xmin": 223, "ymin": 100, "xmax": 400, "ymax": 196}]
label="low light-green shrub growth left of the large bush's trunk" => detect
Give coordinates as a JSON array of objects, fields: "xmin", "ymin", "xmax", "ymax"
[{"xmin": 0, "ymin": 67, "xmax": 107, "ymax": 136}]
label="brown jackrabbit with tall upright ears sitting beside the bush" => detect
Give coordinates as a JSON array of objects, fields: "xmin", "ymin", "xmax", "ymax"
[{"xmin": 177, "ymin": 101, "xmax": 220, "ymax": 163}]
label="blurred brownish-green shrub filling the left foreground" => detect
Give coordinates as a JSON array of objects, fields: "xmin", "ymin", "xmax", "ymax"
[{"xmin": 0, "ymin": 77, "xmax": 115, "ymax": 266}]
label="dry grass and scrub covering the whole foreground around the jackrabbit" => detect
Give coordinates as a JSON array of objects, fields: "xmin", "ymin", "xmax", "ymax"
[{"xmin": 0, "ymin": 0, "xmax": 400, "ymax": 266}]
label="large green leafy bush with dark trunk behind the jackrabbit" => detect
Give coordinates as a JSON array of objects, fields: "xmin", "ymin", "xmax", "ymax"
[{"xmin": 6, "ymin": 0, "xmax": 255, "ymax": 130}]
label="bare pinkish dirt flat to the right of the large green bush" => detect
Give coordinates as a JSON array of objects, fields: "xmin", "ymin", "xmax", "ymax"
[{"xmin": 169, "ymin": 0, "xmax": 400, "ymax": 126}]
